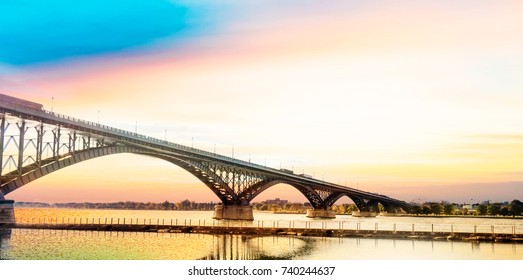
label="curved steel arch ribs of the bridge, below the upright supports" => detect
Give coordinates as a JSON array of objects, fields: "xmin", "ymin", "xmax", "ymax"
[{"xmin": 0, "ymin": 142, "xmax": 410, "ymax": 219}]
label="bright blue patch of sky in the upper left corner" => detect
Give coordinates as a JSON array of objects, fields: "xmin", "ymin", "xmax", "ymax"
[{"xmin": 0, "ymin": 0, "xmax": 203, "ymax": 66}]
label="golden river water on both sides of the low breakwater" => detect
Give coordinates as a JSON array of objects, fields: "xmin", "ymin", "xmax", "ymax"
[{"xmin": 0, "ymin": 208, "xmax": 523, "ymax": 260}]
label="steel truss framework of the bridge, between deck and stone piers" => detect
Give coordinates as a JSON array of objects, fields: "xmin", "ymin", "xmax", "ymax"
[{"xmin": 0, "ymin": 110, "xmax": 412, "ymax": 211}]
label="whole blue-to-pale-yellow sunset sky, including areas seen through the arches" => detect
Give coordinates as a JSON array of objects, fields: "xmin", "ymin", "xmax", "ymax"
[{"xmin": 0, "ymin": 0, "xmax": 523, "ymax": 203}]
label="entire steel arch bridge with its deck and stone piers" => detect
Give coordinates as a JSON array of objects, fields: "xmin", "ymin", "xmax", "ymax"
[{"xmin": 0, "ymin": 94, "xmax": 410, "ymax": 223}]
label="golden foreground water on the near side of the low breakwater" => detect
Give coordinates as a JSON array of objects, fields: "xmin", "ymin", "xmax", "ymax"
[{"xmin": 0, "ymin": 229, "xmax": 523, "ymax": 260}]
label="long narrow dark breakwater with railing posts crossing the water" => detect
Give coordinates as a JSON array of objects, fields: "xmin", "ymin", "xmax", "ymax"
[{"xmin": 0, "ymin": 224, "xmax": 523, "ymax": 243}]
